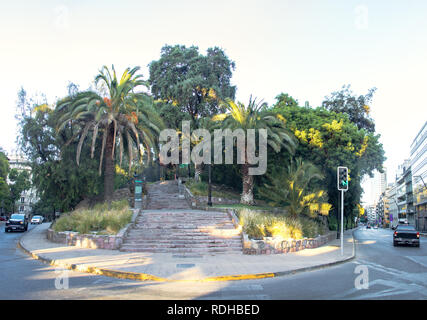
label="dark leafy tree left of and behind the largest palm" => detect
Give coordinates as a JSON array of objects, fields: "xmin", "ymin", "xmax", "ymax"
[{"xmin": 19, "ymin": 90, "xmax": 102, "ymax": 216}]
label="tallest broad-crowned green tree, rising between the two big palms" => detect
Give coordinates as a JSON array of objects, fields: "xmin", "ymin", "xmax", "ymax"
[{"xmin": 149, "ymin": 45, "xmax": 236, "ymax": 120}]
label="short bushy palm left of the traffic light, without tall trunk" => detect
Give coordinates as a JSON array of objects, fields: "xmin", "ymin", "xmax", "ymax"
[{"xmin": 259, "ymin": 158, "xmax": 331, "ymax": 218}]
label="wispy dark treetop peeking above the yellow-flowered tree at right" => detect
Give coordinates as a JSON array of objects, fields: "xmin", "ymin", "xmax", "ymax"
[{"xmin": 322, "ymin": 85, "xmax": 377, "ymax": 133}]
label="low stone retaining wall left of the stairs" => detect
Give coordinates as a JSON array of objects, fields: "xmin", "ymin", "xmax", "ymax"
[{"xmin": 47, "ymin": 210, "xmax": 139, "ymax": 250}]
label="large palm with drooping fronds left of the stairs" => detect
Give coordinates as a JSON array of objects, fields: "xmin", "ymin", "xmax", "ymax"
[{"xmin": 55, "ymin": 66, "xmax": 162, "ymax": 201}]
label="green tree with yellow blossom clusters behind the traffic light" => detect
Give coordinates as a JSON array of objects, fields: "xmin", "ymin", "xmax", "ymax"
[{"xmin": 269, "ymin": 95, "xmax": 385, "ymax": 230}]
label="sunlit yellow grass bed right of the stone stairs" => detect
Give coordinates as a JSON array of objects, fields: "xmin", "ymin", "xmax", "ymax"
[{"xmin": 237, "ymin": 208, "xmax": 324, "ymax": 240}]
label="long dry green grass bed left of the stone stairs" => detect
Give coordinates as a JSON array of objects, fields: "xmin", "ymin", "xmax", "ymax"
[{"xmin": 53, "ymin": 199, "xmax": 132, "ymax": 235}]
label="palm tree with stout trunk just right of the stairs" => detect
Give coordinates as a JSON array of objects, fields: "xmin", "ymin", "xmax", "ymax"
[{"xmin": 213, "ymin": 96, "xmax": 296, "ymax": 205}]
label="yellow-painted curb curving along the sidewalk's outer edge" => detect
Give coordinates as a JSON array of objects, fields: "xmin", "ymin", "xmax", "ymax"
[{"xmin": 17, "ymin": 229, "xmax": 357, "ymax": 282}]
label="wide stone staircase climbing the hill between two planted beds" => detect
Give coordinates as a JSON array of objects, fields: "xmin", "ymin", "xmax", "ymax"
[{"xmin": 120, "ymin": 181, "xmax": 242, "ymax": 255}]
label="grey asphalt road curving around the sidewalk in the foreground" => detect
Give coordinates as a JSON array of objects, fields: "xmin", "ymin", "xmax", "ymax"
[{"xmin": 0, "ymin": 223, "xmax": 427, "ymax": 300}]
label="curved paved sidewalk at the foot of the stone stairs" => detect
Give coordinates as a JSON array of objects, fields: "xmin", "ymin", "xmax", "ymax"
[{"xmin": 19, "ymin": 223, "xmax": 355, "ymax": 281}]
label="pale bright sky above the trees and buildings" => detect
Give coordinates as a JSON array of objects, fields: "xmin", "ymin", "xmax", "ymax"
[{"xmin": 0, "ymin": 0, "xmax": 427, "ymax": 201}]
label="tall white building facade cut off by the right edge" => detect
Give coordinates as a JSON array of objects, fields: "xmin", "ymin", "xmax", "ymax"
[{"xmin": 410, "ymin": 121, "xmax": 427, "ymax": 231}]
